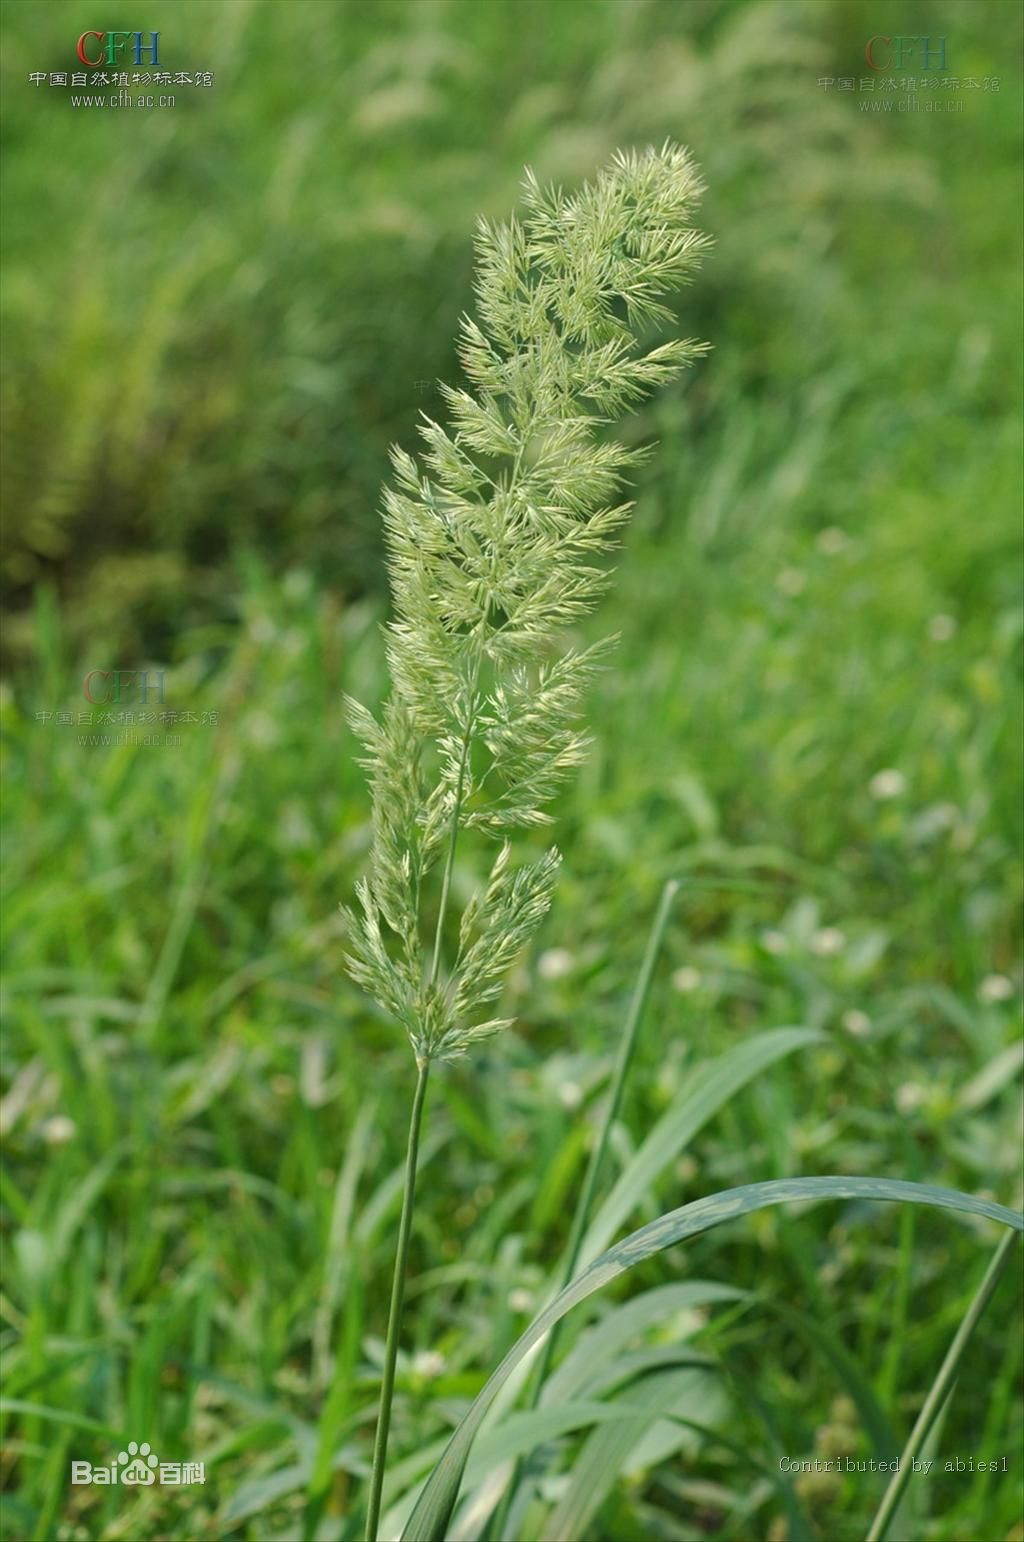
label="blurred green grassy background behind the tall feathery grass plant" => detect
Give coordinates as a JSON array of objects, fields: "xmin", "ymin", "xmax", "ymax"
[{"xmin": 0, "ymin": 0, "xmax": 1024, "ymax": 1542}]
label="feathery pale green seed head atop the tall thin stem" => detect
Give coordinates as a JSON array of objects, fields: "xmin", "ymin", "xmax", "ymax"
[{"xmin": 349, "ymin": 145, "xmax": 708, "ymax": 1061}]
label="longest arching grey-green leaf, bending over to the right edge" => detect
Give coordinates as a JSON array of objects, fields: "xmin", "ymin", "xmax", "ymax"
[{"xmin": 403, "ymin": 1177, "xmax": 1024, "ymax": 1542}]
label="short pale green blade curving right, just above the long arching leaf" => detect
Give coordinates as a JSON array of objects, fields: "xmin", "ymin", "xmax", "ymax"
[{"xmin": 580, "ymin": 1029, "xmax": 825, "ymax": 1264}]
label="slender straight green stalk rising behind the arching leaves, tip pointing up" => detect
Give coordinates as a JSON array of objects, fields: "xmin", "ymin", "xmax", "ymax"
[{"xmin": 492, "ymin": 879, "xmax": 679, "ymax": 1542}]
